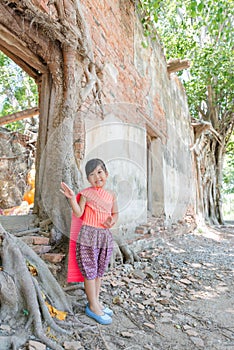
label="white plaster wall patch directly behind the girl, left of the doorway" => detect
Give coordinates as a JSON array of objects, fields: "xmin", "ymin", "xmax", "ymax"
[{"xmin": 83, "ymin": 115, "xmax": 147, "ymax": 232}]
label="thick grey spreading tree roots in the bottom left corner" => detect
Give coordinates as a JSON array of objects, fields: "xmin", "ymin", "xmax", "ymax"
[{"xmin": 0, "ymin": 225, "xmax": 76, "ymax": 350}]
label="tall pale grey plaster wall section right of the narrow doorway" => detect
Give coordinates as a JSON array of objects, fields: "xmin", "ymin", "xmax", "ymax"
[{"xmin": 163, "ymin": 79, "xmax": 196, "ymax": 223}]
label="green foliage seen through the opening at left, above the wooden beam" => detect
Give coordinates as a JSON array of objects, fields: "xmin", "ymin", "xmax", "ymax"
[{"xmin": 0, "ymin": 51, "xmax": 38, "ymax": 130}]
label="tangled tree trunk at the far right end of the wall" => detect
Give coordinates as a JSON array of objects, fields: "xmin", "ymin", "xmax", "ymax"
[{"xmin": 192, "ymin": 85, "xmax": 234, "ymax": 225}]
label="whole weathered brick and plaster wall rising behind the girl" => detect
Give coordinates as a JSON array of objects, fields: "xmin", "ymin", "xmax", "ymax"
[{"xmin": 78, "ymin": 0, "xmax": 195, "ymax": 226}]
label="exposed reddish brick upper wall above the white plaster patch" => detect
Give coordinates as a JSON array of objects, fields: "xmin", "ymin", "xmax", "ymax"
[{"xmin": 80, "ymin": 0, "xmax": 168, "ymax": 135}]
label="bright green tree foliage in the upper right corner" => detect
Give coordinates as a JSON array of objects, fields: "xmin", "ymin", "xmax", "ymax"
[{"xmin": 138, "ymin": 0, "xmax": 234, "ymax": 121}]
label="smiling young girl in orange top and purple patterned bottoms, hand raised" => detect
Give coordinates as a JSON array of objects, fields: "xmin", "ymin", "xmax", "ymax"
[{"xmin": 61, "ymin": 159, "xmax": 118, "ymax": 324}]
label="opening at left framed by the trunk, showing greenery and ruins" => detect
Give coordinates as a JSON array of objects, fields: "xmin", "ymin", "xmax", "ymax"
[{"xmin": 0, "ymin": 51, "xmax": 39, "ymax": 215}]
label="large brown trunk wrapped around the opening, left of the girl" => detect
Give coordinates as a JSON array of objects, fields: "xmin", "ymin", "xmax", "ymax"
[{"xmin": 0, "ymin": 0, "xmax": 100, "ymax": 234}]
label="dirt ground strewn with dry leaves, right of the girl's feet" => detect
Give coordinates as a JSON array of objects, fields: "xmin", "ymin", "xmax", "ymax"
[{"xmin": 59, "ymin": 225, "xmax": 234, "ymax": 350}]
